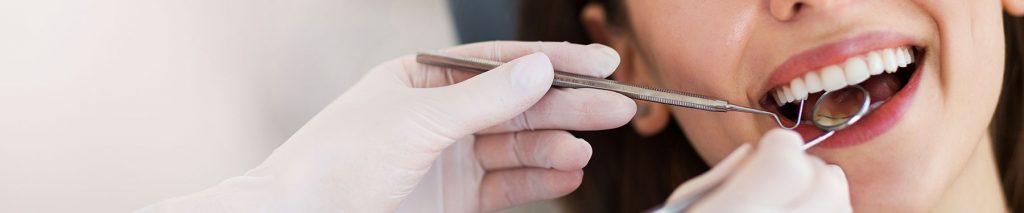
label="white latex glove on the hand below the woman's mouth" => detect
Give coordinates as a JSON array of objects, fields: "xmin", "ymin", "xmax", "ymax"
[{"xmin": 668, "ymin": 129, "xmax": 853, "ymax": 212}]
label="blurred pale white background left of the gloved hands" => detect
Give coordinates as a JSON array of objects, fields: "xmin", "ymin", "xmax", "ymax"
[{"xmin": 0, "ymin": 0, "xmax": 455, "ymax": 212}]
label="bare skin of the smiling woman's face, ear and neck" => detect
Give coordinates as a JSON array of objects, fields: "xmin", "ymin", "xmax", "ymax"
[{"xmin": 583, "ymin": 0, "xmax": 1022, "ymax": 212}]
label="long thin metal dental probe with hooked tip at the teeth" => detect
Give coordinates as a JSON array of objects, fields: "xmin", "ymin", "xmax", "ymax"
[{"xmin": 416, "ymin": 52, "xmax": 804, "ymax": 129}]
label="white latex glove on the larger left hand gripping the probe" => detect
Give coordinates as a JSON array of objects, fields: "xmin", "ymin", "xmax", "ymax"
[{"xmin": 136, "ymin": 42, "xmax": 636, "ymax": 212}]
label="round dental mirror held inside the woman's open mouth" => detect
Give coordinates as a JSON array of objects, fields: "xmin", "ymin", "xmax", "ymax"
[{"xmin": 803, "ymin": 85, "xmax": 871, "ymax": 150}]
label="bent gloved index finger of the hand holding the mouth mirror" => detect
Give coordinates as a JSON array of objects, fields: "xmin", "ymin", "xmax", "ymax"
[{"xmin": 694, "ymin": 129, "xmax": 814, "ymax": 211}]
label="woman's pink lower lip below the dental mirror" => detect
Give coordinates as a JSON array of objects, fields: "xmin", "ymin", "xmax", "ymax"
[{"xmin": 794, "ymin": 61, "xmax": 925, "ymax": 148}]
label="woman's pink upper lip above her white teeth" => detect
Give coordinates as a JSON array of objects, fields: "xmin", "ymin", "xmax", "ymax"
[{"xmin": 760, "ymin": 32, "xmax": 914, "ymax": 102}]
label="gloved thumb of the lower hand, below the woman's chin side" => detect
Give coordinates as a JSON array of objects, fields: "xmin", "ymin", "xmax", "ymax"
[{"xmin": 666, "ymin": 143, "xmax": 751, "ymax": 203}]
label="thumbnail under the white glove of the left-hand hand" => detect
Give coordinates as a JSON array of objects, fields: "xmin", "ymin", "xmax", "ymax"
[{"xmin": 511, "ymin": 52, "xmax": 554, "ymax": 90}]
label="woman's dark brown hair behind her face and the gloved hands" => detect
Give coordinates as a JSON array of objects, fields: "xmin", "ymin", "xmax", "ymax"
[{"xmin": 518, "ymin": 0, "xmax": 1024, "ymax": 212}]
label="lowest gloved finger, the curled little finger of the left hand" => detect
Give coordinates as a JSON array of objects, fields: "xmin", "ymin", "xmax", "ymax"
[{"xmin": 480, "ymin": 168, "xmax": 583, "ymax": 212}]
